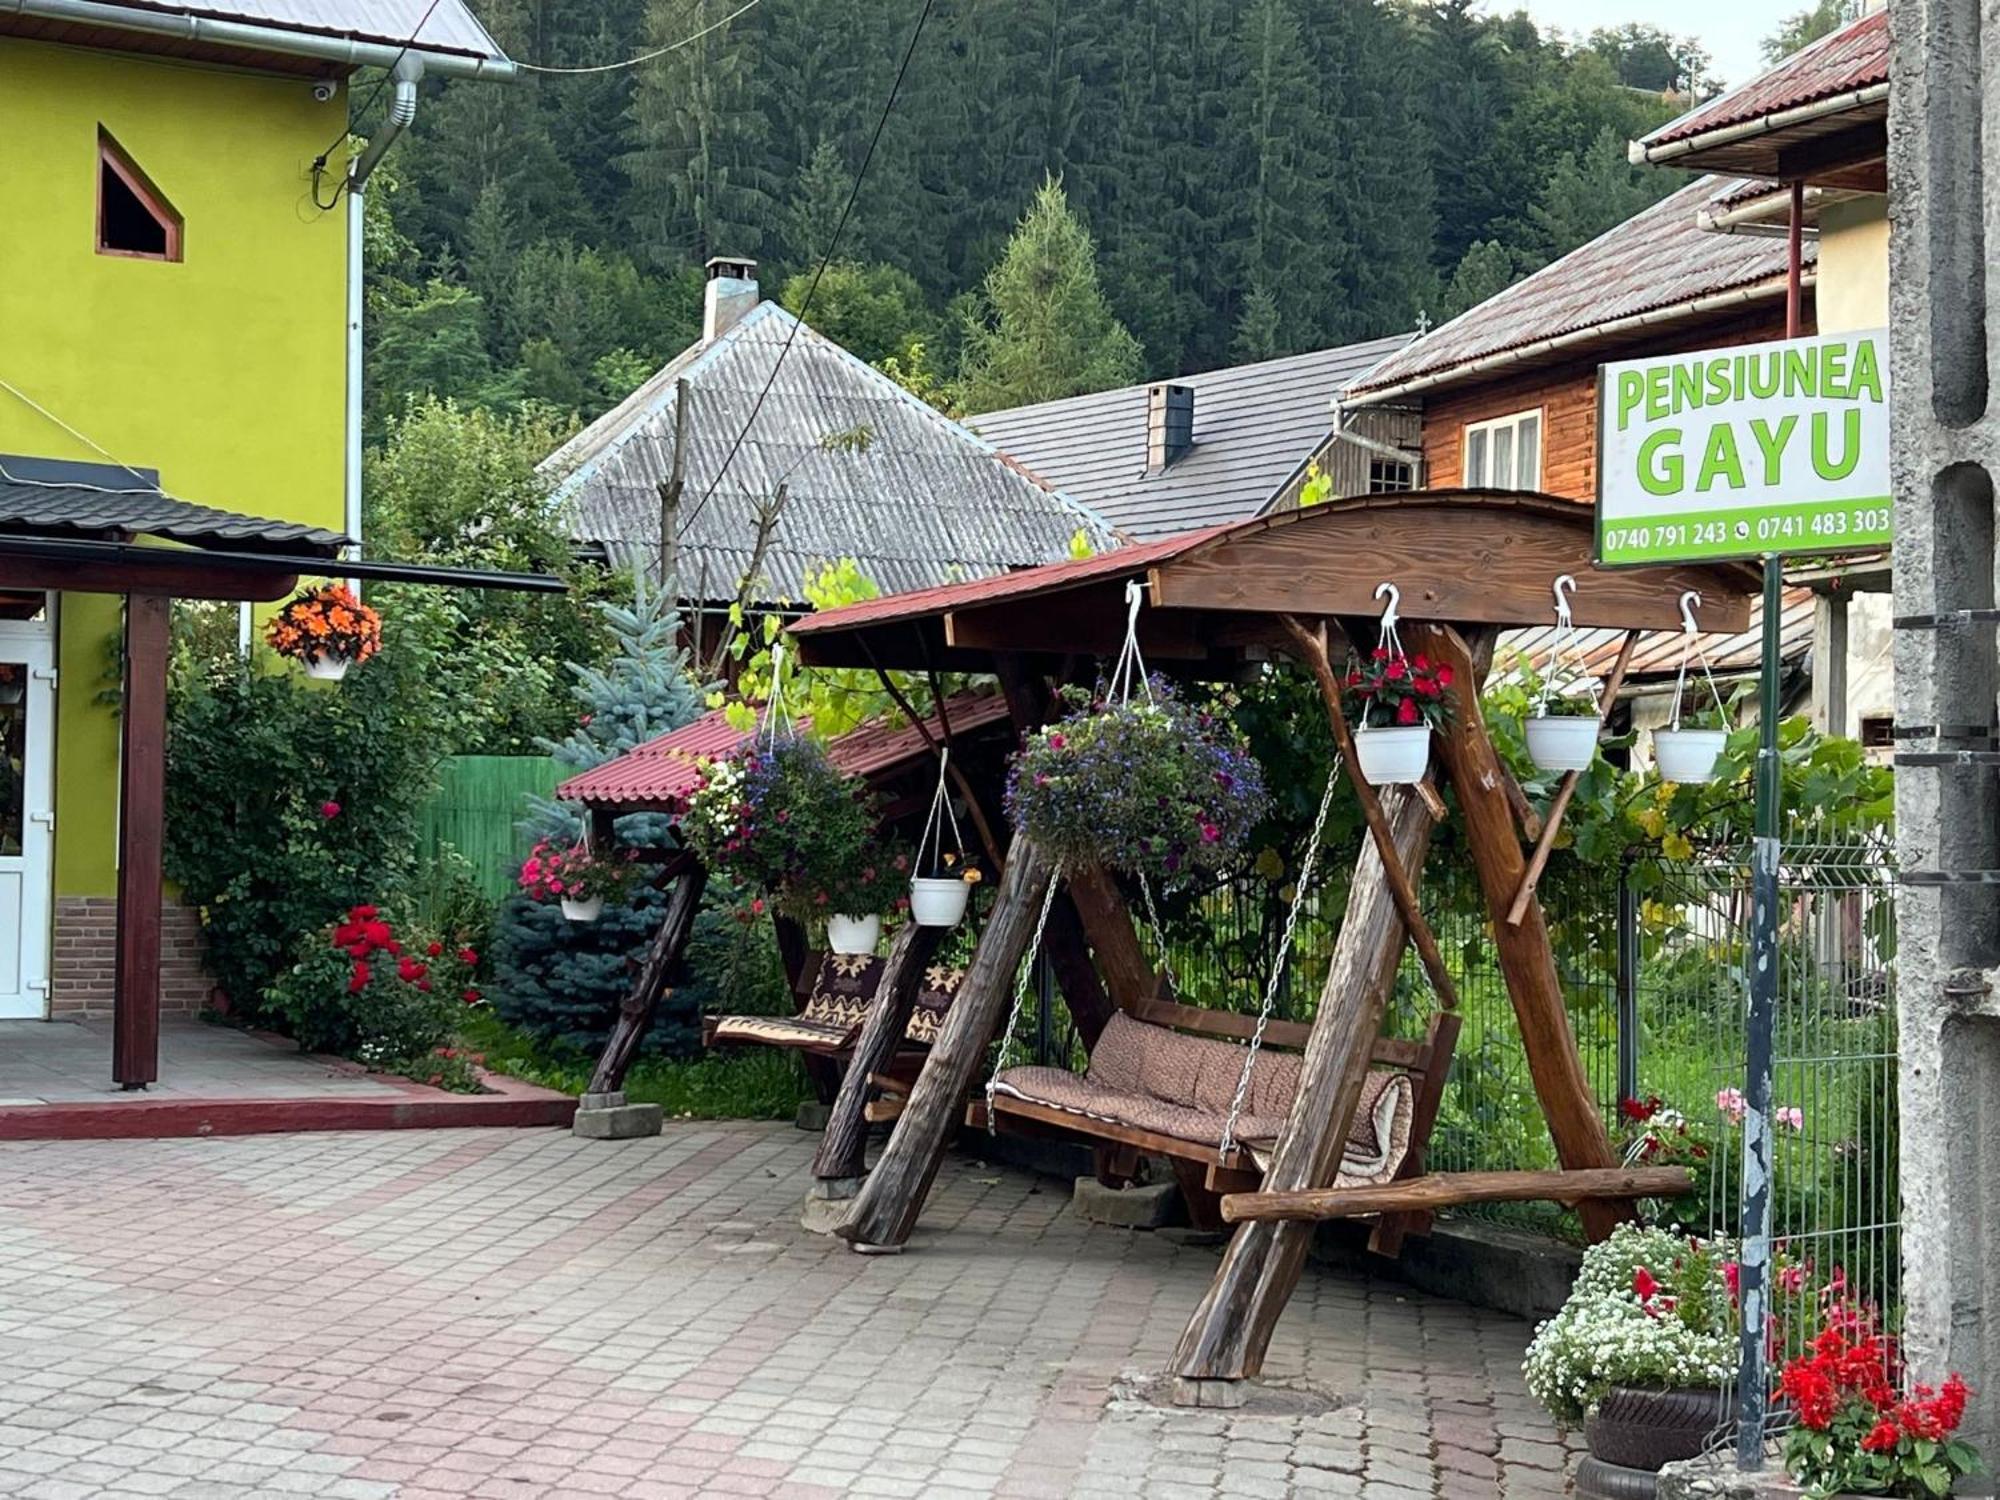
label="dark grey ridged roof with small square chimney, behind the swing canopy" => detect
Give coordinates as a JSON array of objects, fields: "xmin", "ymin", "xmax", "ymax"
[{"xmin": 966, "ymin": 334, "xmax": 1412, "ymax": 540}]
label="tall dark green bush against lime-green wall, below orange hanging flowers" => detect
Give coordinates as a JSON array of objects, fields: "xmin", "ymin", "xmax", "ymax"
[{"xmin": 166, "ymin": 648, "xmax": 436, "ymax": 1020}]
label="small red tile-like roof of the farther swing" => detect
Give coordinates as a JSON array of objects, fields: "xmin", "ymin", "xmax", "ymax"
[{"xmin": 556, "ymin": 694, "xmax": 1008, "ymax": 810}]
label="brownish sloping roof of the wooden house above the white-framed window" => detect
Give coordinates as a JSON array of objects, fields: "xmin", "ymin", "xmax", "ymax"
[{"xmin": 1346, "ymin": 178, "xmax": 1818, "ymax": 400}]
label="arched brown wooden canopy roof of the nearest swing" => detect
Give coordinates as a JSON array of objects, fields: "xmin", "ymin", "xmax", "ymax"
[{"xmin": 790, "ymin": 490, "xmax": 1758, "ymax": 670}]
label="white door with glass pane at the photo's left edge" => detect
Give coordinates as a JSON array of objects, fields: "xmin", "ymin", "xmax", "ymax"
[{"xmin": 0, "ymin": 620, "xmax": 56, "ymax": 1020}]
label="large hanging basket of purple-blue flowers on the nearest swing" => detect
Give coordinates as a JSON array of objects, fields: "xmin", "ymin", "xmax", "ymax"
[{"xmin": 1006, "ymin": 678, "xmax": 1268, "ymax": 880}]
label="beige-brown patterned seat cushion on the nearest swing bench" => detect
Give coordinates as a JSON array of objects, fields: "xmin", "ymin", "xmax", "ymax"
[{"xmin": 994, "ymin": 1014, "xmax": 1416, "ymax": 1186}]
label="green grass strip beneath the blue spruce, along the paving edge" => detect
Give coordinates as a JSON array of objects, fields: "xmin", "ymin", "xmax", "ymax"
[{"xmin": 460, "ymin": 1008, "xmax": 812, "ymax": 1120}]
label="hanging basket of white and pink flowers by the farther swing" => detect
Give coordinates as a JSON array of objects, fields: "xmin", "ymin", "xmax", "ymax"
[{"xmin": 680, "ymin": 734, "xmax": 910, "ymax": 936}]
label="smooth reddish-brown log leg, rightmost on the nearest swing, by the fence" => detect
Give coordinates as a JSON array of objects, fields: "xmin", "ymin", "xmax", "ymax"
[{"xmin": 1416, "ymin": 626, "xmax": 1634, "ymax": 1240}]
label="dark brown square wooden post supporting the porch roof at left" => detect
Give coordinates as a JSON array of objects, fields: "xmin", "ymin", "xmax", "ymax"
[{"xmin": 112, "ymin": 594, "xmax": 172, "ymax": 1088}]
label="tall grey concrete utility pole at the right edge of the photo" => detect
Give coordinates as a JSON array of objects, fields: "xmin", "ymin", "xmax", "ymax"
[{"xmin": 1890, "ymin": 0, "xmax": 2000, "ymax": 1452}]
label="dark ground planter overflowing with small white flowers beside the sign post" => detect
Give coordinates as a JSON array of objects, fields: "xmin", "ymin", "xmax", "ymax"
[{"xmin": 1522, "ymin": 1224, "xmax": 1738, "ymax": 1496}]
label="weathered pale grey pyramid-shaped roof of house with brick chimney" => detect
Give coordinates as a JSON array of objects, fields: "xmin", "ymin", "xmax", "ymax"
[{"xmin": 544, "ymin": 302, "xmax": 1116, "ymax": 600}]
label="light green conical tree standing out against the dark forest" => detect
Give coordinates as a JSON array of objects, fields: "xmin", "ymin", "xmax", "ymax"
[{"xmin": 962, "ymin": 176, "xmax": 1142, "ymax": 412}]
